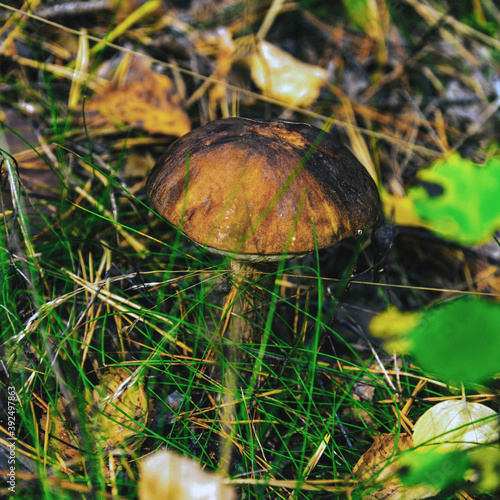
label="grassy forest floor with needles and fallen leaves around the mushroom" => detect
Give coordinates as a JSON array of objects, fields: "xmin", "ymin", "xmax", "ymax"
[{"xmin": 0, "ymin": 0, "xmax": 500, "ymax": 500}]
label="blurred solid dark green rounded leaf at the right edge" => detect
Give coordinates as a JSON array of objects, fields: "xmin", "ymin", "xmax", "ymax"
[{"xmin": 409, "ymin": 298, "xmax": 500, "ymax": 384}]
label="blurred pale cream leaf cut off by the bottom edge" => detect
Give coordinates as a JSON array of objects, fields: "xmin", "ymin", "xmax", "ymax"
[{"xmin": 139, "ymin": 451, "xmax": 235, "ymax": 500}]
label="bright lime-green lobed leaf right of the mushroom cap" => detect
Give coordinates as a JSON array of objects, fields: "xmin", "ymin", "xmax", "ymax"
[{"xmin": 407, "ymin": 153, "xmax": 500, "ymax": 245}]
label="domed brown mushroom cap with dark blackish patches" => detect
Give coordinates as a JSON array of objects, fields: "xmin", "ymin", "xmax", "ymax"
[{"xmin": 146, "ymin": 118, "xmax": 381, "ymax": 261}]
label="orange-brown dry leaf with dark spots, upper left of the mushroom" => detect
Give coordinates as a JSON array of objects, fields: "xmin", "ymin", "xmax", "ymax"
[{"xmin": 85, "ymin": 55, "xmax": 191, "ymax": 137}]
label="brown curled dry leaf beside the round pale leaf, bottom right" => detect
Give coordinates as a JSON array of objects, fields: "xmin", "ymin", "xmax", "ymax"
[{"xmin": 353, "ymin": 433, "xmax": 436, "ymax": 500}]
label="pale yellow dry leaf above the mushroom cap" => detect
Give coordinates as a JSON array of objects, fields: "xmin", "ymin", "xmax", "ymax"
[{"xmin": 247, "ymin": 41, "xmax": 328, "ymax": 107}]
